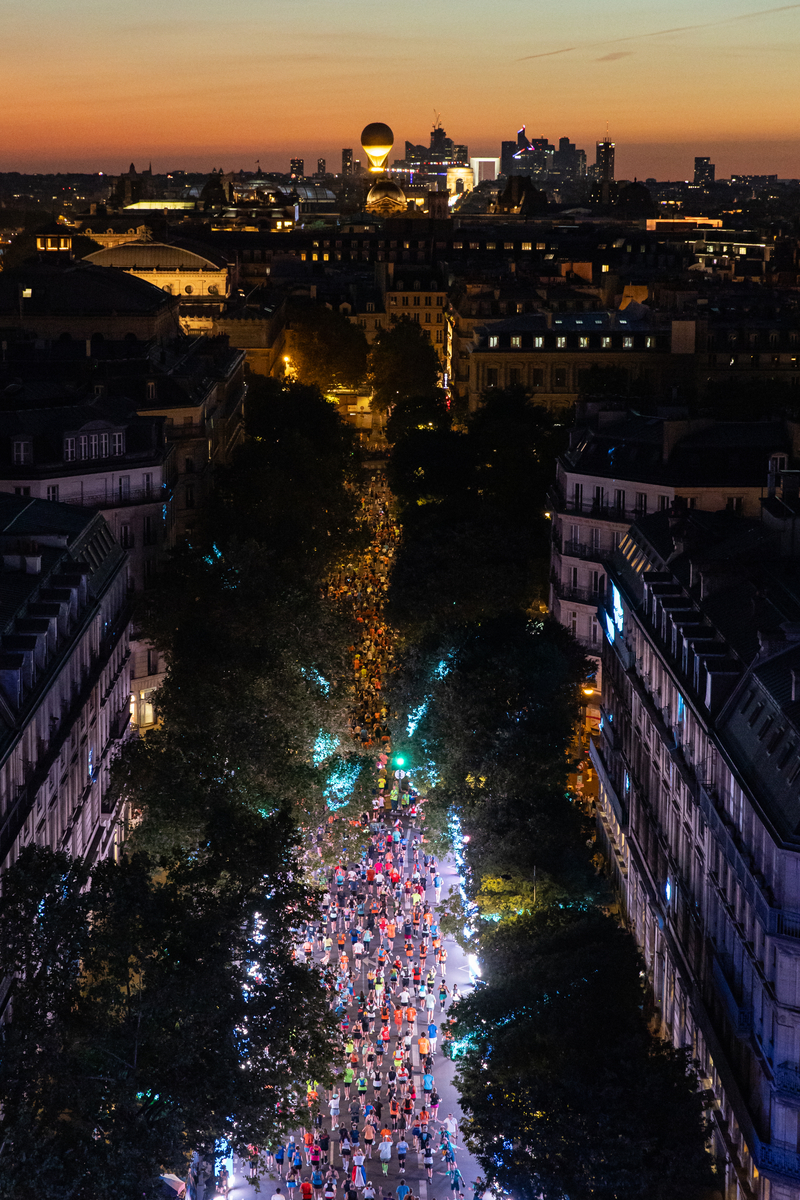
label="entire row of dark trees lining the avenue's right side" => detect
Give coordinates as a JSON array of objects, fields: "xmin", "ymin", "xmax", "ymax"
[{"xmin": 390, "ymin": 391, "xmax": 714, "ymax": 1200}]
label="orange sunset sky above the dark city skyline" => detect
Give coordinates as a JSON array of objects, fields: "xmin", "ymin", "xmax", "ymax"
[{"xmin": 0, "ymin": 0, "xmax": 800, "ymax": 179}]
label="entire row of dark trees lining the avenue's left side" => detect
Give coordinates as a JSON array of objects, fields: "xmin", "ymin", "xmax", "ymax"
[{"xmin": 0, "ymin": 378, "xmax": 365, "ymax": 1200}]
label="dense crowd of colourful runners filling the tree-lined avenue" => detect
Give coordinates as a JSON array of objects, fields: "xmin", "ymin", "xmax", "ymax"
[{"xmin": 219, "ymin": 474, "xmax": 483, "ymax": 1200}]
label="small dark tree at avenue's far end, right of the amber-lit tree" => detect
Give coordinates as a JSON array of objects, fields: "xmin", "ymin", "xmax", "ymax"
[{"xmin": 369, "ymin": 317, "xmax": 441, "ymax": 412}]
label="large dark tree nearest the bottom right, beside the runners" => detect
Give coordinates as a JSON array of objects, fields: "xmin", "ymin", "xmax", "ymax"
[{"xmin": 453, "ymin": 905, "xmax": 714, "ymax": 1200}]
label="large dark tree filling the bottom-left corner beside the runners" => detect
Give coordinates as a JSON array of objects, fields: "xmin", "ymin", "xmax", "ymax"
[{"xmin": 0, "ymin": 830, "xmax": 335, "ymax": 1200}]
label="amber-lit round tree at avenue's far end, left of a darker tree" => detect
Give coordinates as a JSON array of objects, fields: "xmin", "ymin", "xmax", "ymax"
[{"xmin": 289, "ymin": 304, "xmax": 368, "ymax": 391}]
